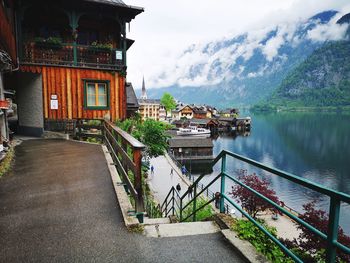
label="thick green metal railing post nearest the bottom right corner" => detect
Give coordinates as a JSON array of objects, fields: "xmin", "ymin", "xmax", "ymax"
[{"xmin": 326, "ymin": 197, "xmax": 340, "ymax": 263}]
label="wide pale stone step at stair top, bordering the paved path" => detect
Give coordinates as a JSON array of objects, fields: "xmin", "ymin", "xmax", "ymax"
[{"xmin": 144, "ymin": 221, "xmax": 220, "ymax": 237}]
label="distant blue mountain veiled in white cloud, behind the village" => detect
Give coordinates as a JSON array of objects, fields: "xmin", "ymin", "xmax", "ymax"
[{"xmin": 144, "ymin": 10, "xmax": 345, "ymax": 107}]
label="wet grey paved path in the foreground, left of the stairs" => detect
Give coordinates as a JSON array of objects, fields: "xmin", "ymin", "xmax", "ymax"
[{"xmin": 0, "ymin": 140, "xmax": 243, "ymax": 262}]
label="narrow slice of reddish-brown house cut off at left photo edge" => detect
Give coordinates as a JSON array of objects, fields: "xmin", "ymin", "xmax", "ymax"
[{"xmin": 0, "ymin": 0, "xmax": 18, "ymax": 146}]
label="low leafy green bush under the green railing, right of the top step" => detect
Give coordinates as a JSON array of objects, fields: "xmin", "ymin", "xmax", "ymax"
[{"xmin": 231, "ymin": 219, "xmax": 294, "ymax": 263}]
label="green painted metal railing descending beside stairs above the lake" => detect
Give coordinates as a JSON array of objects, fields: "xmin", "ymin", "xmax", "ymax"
[{"xmin": 163, "ymin": 151, "xmax": 350, "ymax": 263}]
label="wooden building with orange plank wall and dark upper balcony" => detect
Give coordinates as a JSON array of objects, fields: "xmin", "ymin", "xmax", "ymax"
[{"xmin": 7, "ymin": 0, "xmax": 143, "ymax": 135}]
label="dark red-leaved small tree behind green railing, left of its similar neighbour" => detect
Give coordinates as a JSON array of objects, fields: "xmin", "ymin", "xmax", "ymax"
[{"xmin": 230, "ymin": 173, "xmax": 280, "ymax": 218}]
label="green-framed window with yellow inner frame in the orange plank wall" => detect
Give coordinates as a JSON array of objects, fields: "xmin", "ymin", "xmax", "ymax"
[{"xmin": 84, "ymin": 80, "xmax": 109, "ymax": 110}]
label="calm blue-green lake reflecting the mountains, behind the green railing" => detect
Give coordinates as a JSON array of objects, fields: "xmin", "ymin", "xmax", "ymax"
[{"xmin": 186, "ymin": 112, "xmax": 350, "ymax": 234}]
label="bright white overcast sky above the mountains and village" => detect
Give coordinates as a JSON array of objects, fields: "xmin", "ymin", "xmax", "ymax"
[{"xmin": 124, "ymin": 0, "xmax": 350, "ymax": 89}]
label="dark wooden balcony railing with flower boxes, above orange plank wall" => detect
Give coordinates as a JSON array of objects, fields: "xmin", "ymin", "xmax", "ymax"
[{"xmin": 21, "ymin": 42, "xmax": 124, "ymax": 70}]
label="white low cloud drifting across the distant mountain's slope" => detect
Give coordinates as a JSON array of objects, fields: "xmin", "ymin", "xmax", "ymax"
[{"xmin": 147, "ymin": 9, "xmax": 347, "ymax": 87}]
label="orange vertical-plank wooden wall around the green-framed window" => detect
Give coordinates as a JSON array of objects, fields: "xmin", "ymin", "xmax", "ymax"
[{"xmin": 21, "ymin": 66, "xmax": 126, "ymax": 121}]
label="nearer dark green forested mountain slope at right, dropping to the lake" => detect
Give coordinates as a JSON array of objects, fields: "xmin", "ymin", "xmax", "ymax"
[{"xmin": 268, "ymin": 41, "xmax": 350, "ymax": 106}]
